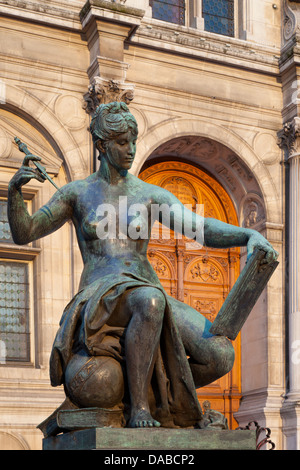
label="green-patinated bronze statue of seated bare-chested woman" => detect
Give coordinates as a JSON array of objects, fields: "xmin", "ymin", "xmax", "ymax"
[{"xmin": 8, "ymin": 102, "xmax": 278, "ymax": 427}]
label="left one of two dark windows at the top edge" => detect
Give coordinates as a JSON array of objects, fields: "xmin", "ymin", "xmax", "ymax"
[{"xmin": 150, "ymin": 0, "xmax": 185, "ymax": 25}]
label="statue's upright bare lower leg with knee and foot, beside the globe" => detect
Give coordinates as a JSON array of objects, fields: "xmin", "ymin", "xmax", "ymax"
[{"xmin": 109, "ymin": 287, "xmax": 166, "ymax": 427}]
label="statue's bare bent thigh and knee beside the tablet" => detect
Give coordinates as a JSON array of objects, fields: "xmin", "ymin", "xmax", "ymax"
[{"xmin": 168, "ymin": 297, "xmax": 235, "ymax": 388}]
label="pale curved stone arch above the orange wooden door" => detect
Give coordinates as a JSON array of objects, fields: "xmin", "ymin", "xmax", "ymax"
[{"xmin": 132, "ymin": 114, "xmax": 282, "ymax": 229}]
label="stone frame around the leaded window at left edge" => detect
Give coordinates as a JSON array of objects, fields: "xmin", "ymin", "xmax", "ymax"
[{"xmin": 0, "ymin": 187, "xmax": 41, "ymax": 367}]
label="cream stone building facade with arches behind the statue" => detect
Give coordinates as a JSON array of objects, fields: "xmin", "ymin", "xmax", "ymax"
[{"xmin": 0, "ymin": 0, "xmax": 300, "ymax": 449}]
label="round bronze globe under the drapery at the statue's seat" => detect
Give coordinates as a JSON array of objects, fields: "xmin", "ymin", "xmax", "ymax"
[{"xmin": 65, "ymin": 352, "xmax": 124, "ymax": 408}]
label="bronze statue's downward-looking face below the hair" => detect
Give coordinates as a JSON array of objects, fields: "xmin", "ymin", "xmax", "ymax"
[{"xmin": 106, "ymin": 129, "xmax": 137, "ymax": 170}]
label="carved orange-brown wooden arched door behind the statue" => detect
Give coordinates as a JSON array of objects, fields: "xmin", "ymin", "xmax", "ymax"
[{"xmin": 140, "ymin": 162, "xmax": 241, "ymax": 429}]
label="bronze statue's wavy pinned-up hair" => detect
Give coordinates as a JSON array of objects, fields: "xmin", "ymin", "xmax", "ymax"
[{"xmin": 90, "ymin": 101, "xmax": 138, "ymax": 159}]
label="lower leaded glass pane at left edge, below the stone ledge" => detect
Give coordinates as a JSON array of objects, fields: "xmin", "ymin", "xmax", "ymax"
[{"xmin": 0, "ymin": 261, "xmax": 29, "ymax": 363}]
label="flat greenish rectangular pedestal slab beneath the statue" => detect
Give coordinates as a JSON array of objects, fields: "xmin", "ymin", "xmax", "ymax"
[{"xmin": 43, "ymin": 428, "xmax": 256, "ymax": 452}]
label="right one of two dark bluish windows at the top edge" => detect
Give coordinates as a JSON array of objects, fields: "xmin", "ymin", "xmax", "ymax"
[{"xmin": 202, "ymin": 0, "xmax": 234, "ymax": 36}]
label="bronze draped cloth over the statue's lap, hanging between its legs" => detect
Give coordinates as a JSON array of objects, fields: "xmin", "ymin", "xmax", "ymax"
[{"xmin": 50, "ymin": 272, "xmax": 202, "ymax": 427}]
